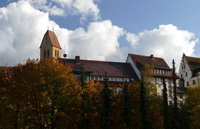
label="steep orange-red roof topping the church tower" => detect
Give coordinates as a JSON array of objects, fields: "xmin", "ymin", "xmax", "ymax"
[{"xmin": 40, "ymin": 30, "xmax": 61, "ymax": 48}]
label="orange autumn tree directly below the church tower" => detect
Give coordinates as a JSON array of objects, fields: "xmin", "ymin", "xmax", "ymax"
[{"xmin": 37, "ymin": 60, "xmax": 81, "ymax": 128}]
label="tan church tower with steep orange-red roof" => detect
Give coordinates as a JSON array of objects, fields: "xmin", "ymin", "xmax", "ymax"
[{"xmin": 40, "ymin": 30, "xmax": 62, "ymax": 59}]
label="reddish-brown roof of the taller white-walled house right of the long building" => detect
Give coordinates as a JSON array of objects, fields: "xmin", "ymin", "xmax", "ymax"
[{"xmin": 128, "ymin": 54, "xmax": 170, "ymax": 70}]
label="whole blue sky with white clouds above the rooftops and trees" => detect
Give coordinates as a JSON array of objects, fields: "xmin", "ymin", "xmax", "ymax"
[{"xmin": 0, "ymin": 0, "xmax": 200, "ymax": 67}]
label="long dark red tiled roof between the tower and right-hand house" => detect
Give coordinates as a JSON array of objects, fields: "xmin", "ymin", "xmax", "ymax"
[{"xmin": 59, "ymin": 58, "xmax": 138, "ymax": 81}]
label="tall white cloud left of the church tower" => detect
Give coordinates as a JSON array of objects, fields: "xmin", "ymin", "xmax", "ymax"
[{"xmin": 0, "ymin": 1, "xmax": 53, "ymax": 65}]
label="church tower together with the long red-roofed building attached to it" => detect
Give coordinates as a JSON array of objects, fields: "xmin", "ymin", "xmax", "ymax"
[{"xmin": 40, "ymin": 30, "xmax": 139, "ymax": 85}]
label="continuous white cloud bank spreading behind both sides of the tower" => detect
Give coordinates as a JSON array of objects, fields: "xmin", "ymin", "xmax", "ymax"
[{"xmin": 0, "ymin": 1, "xmax": 121, "ymax": 65}]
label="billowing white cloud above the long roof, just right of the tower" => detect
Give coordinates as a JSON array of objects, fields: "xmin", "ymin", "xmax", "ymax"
[{"xmin": 65, "ymin": 20, "xmax": 124, "ymax": 60}]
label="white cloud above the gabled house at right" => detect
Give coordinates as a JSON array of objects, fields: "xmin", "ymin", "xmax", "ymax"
[{"xmin": 126, "ymin": 24, "xmax": 198, "ymax": 67}]
